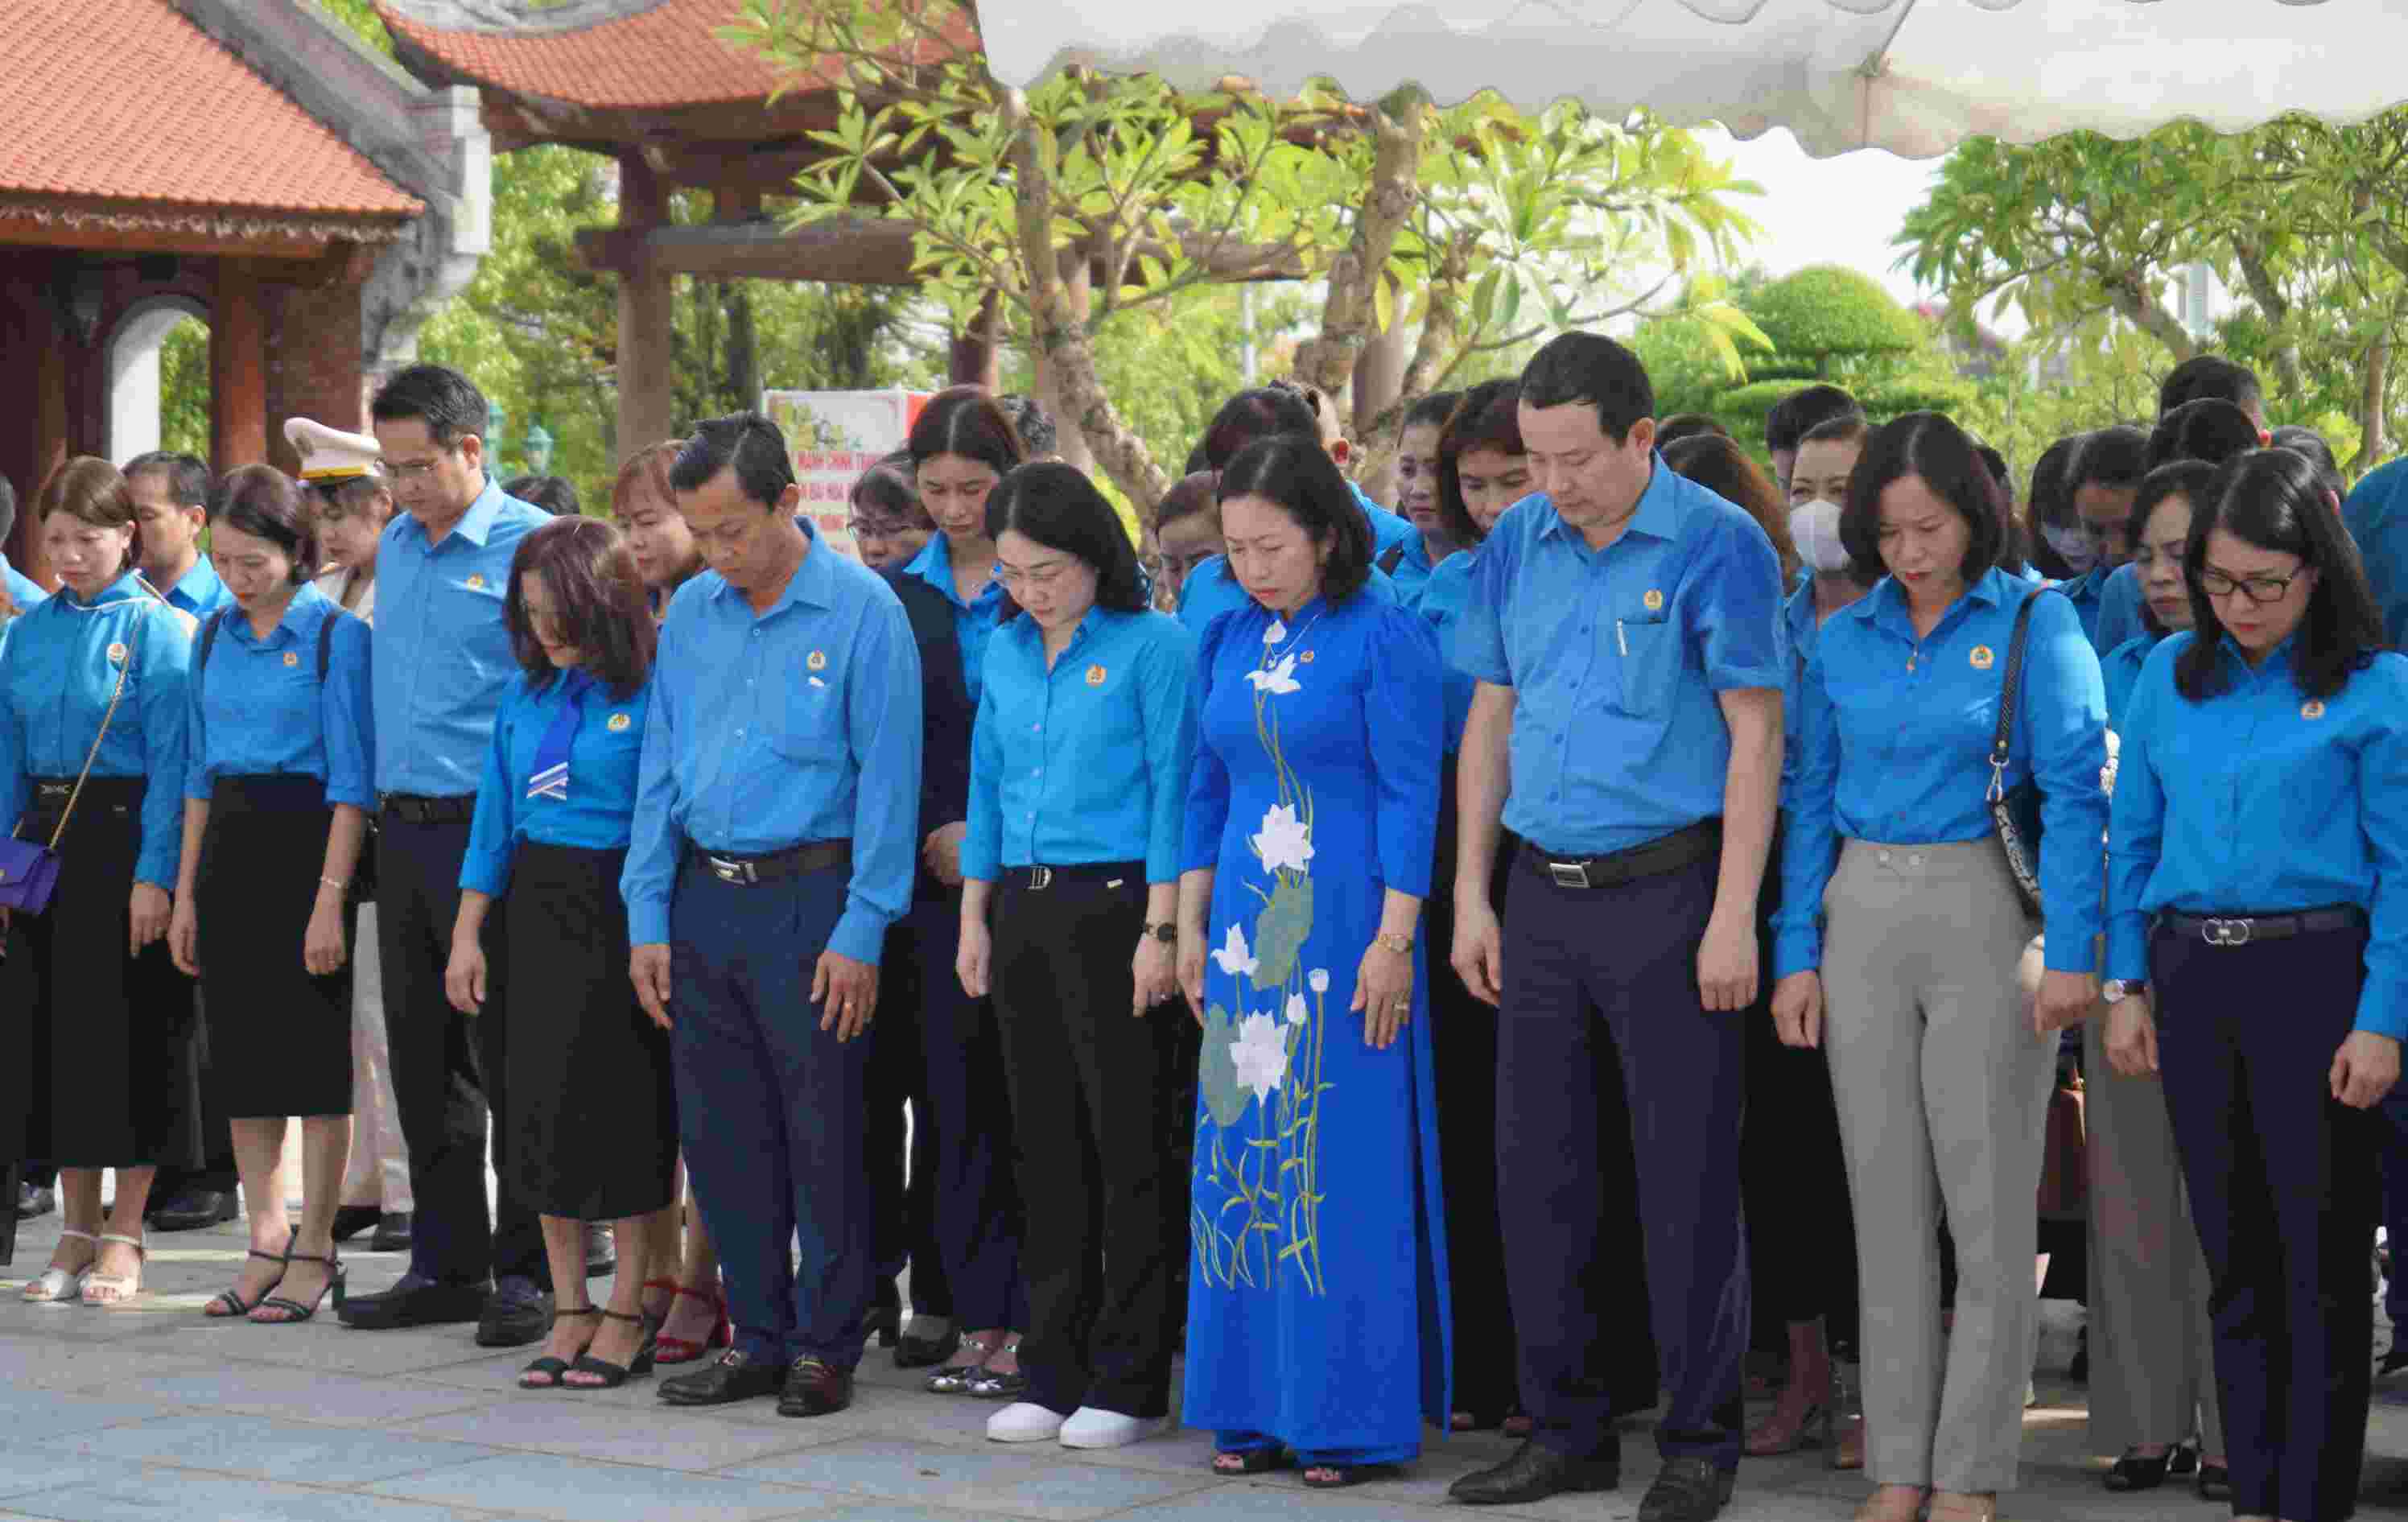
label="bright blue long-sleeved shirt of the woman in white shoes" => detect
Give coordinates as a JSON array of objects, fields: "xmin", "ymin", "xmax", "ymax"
[{"xmin": 961, "ymin": 607, "xmax": 1197, "ymax": 884}]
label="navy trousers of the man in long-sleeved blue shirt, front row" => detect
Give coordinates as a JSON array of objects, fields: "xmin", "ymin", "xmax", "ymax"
[{"xmin": 670, "ymin": 860, "xmax": 876, "ymax": 1368}]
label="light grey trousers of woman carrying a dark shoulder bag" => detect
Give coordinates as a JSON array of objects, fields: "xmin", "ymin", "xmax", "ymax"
[{"xmin": 1823, "ymin": 840, "xmax": 2056, "ymax": 1493}]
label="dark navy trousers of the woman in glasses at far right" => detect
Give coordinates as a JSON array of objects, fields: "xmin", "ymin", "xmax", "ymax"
[{"xmin": 2150, "ymin": 930, "xmax": 2381, "ymax": 1522}]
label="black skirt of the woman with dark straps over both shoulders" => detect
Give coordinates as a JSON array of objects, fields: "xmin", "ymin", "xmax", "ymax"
[{"xmin": 192, "ymin": 775, "xmax": 357, "ymax": 1120}]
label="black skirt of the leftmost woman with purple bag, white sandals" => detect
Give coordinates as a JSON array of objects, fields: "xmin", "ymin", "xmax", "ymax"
[{"xmin": 5, "ymin": 777, "xmax": 202, "ymax": 1168}]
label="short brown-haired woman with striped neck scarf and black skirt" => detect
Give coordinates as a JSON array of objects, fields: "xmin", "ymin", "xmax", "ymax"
[{"xmin": 443, "ymin": 518, "xmax": 677, "ymax": 1389}]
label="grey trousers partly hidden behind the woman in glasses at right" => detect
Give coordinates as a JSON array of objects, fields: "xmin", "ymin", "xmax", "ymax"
[{"xmin": 2083, "ymin": 1012, "xmax": 2225, "ymax": 1454}]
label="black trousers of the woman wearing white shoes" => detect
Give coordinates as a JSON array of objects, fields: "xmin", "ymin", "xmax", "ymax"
[{"xmin": 992, "ymin": 862, "xmax": 1187, "ymax": 1416}]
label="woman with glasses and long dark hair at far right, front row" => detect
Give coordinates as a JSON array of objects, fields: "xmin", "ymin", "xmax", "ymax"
[{"xmin": 2107, "ymin": 448, "xmax": 2408, "ymax": 1522}]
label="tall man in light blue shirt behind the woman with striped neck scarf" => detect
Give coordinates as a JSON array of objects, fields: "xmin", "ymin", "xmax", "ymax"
[{"xmin": 340, "ymin": 364, "xmax": 551, "ymax": 1349}]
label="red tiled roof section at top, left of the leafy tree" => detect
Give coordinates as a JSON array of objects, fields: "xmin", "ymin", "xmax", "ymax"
[{"xmin": 380, "ymin": 0, "xmax": 804, "ymax": 111}]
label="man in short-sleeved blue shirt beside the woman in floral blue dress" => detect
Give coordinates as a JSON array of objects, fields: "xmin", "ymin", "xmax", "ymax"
[{"xmin": 1452, "ymin": 332, "xmax": 1782, "ymax": 1522}]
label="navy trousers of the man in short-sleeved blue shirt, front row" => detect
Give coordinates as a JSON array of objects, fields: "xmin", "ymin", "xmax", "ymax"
[{"xmin": 1498, "ymin": 857, "xmax": 1748, "ymax": 1471}]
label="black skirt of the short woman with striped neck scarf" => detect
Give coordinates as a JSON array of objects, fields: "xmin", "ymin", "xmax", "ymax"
[{"xmin": 503, "ymin": 840, "xmax": 677, "ymax": 1221}]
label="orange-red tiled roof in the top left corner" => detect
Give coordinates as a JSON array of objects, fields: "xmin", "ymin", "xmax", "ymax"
[{"xmin": 0, "ymin": 0, "xmax": 427, "ymax": 217}]
